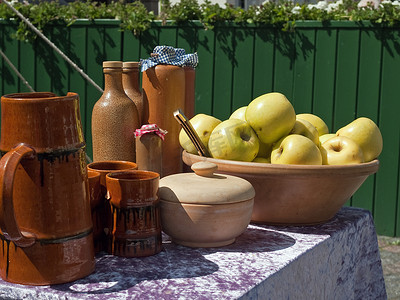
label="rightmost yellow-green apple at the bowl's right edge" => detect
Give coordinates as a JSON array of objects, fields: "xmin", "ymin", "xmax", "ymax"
[{"xmin": 336, "ymin": 117, "xmax": 383, "ymax": 162}]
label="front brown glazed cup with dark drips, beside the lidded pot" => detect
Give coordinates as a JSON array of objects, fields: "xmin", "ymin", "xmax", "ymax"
[{"xmin": 106, "ymin": 170, "xmax": 162, "ymax": 257}]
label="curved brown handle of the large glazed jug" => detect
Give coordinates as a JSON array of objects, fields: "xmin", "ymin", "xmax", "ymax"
[{"xmin": 0, "ymin": 144, "xmax": 36, "ymax": 247}]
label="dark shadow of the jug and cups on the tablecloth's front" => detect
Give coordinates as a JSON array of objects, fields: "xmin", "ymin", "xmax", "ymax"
[{"xmin": 51, "ymin": 244, "xmax": 218, "ymax": 295}]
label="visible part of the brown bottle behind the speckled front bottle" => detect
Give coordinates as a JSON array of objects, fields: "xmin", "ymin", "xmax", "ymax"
[{"xmin": 122, "ymin": 61, "xmax": 144, "ymax": 125}]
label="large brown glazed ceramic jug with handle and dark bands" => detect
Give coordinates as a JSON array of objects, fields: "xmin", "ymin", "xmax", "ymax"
[{"xmin": 0, "ymin": 92, "xmax": 95, "ymax": 285}]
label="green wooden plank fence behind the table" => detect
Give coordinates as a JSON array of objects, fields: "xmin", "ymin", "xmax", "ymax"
[{"xmin": 0, "ymin": 20, "xmax": 400, "ymax": 236}]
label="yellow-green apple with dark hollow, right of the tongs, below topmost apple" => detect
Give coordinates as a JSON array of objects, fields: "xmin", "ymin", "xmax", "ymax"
[{"xmin": 208, "ymin": 119, "xmax": 260, "ymax": 161}]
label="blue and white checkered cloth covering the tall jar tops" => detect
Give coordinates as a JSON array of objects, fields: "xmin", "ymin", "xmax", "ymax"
[{"xmin": 140, "ymin": 46, "xmax": 199, "ymax": 72}]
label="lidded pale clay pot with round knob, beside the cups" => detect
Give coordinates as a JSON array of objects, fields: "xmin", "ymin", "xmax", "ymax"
[{"xmin": 159, "ymin": 162, "xmax": 255, "ymax": 247}]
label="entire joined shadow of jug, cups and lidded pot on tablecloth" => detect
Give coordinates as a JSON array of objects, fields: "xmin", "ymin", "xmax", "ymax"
[{"xmin": 51, "ymin": 227, "xmax": 295, "ymax": 296}]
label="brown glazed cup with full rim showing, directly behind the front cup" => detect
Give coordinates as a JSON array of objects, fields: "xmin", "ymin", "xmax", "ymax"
[{"xmin": 87, "ymin": 160, "xmax": 138, "ymax": 253}]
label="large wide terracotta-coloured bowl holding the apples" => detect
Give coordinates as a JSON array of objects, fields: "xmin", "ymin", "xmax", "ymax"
[{"xmin": 182, "ymin": 151, "xmax": 379, "ymax": 225}]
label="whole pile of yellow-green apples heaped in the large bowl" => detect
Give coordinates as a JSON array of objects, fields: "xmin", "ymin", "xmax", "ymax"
[{"xmin": 179, "ymin": 92, "xmax": 383, "ymax": 165}]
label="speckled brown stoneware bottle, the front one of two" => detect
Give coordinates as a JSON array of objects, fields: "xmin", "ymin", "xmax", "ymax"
[{"xmin": 92, "ymin": 61, "xmax": 140, "ymax": 162}]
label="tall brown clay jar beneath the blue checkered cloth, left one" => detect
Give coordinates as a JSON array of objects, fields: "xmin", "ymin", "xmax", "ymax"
[{"xmin": 142, "ymin": 65, "xmax": 186, "ymax": 177}]
